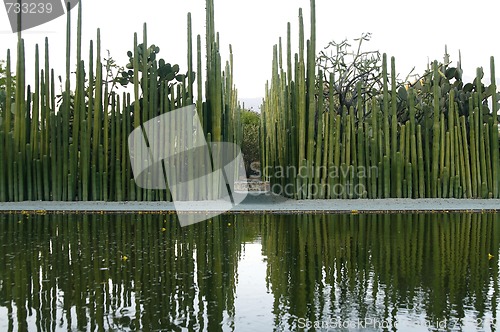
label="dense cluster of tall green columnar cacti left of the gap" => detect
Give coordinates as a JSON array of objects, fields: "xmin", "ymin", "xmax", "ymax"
[{"xmin": 0, "ymin": 0, "xmax": 241, "ymax": 201}]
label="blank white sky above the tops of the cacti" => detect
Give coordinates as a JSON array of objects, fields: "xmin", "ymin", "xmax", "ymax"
[{"xmin": 0, "ymin": 0, "xmax": 500, "ymax": 98}]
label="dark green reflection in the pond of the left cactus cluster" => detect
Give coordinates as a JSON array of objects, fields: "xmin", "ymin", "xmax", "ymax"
[{"xmin": 0, "ymin": 215, "xmax": 243, "ymax": 331}]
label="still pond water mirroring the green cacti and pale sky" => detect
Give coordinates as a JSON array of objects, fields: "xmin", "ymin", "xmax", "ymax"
[{"xmin": 0, "ymin": 213, "xmax": 500, "ymax": 331}]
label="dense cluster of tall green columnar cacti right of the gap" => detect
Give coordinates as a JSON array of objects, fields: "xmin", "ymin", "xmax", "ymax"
[{"xmin": 261, "ymin": 0, "xmax": 500, "ymax": 199}]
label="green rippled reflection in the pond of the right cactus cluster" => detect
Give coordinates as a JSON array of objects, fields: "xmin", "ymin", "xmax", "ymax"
[{"xmin": 262, "ymin": 214, "xmax": 500, "ymax": 330}]
